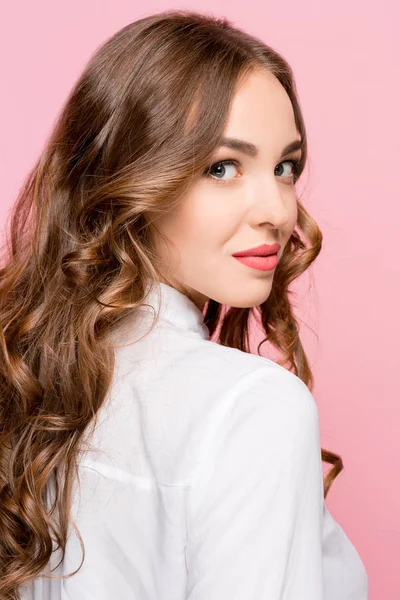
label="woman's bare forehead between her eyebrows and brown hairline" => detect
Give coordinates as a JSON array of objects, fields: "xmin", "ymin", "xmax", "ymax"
[{"xmin": 224, "ymin": 69, "xmax": 298, "ymax": 147}]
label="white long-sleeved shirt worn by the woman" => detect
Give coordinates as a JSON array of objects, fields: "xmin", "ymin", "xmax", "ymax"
[{"xmin": 22, "ymin": 283, "xmax": 368, "ymax": 600}]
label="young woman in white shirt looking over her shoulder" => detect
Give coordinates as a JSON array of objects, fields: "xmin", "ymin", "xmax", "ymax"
[{"xmin": 0, "ymin": 11, "xmax": 367, "ymax": 600}]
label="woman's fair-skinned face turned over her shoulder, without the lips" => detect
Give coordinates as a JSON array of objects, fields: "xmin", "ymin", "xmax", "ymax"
[{"xmin": 152, "ymin": 71, "xmax": 300, "ymax": 310}]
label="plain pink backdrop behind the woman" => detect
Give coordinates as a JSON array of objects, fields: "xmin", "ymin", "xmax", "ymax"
[{"xmin": 0, "ymin": 0, "xmax": 400, "ymax": 600}]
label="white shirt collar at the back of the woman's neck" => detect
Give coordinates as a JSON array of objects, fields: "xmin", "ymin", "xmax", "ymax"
[{"xmin": 144, "ymin": 280, "xmax": 209, "ymax": 339}]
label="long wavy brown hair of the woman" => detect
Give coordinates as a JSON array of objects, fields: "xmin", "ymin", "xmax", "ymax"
[{"xmin": 0, "ymin": 10, "xmax": 343, "ymax": 600}]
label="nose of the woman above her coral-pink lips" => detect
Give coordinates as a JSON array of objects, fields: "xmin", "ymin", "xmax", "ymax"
[{"xmin": 249, "ymin": 177, "xmax": 293, "ymax": 229}]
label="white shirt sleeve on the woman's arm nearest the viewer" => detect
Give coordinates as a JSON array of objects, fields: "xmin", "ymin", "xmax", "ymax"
[{"xmin": 186, "ymin": 368, "xmax": 324, "ymax": 600}]
